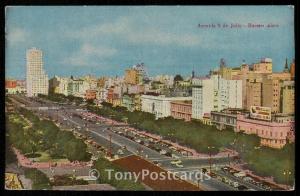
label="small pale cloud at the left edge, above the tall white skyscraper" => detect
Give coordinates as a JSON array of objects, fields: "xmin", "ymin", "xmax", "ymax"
[{"xmin": 6, "ymin": 28, "xmax": 29, "ymax": 44}]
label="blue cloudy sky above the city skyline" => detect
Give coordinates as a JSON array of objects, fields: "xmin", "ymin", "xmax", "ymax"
[{"xmin": 5, "ymin": 6, "xmax": 295, "ymax": 79}]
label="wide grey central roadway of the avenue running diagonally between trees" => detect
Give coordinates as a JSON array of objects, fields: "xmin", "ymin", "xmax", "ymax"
[{"xmin": 8, "ymin": 96, "xmax": 259, "ymax": 190}]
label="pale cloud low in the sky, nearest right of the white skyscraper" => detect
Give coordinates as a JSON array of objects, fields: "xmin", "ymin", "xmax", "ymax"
[{"xmin": 62, "ymin": 43, "xmax": 117, "ymax": 66}]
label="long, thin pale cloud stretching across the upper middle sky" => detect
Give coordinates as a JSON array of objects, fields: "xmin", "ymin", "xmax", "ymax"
[{"xmin": 67, "ymin": 17, "xmax": 200, "ymax": 46}]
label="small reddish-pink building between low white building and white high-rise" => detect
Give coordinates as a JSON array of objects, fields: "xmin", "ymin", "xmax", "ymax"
[{"xmin": 171, "ymin": 100, "xmax": 192, "ymax": 121}]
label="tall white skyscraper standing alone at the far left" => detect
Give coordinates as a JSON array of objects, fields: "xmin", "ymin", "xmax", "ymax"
[{"xmin": 26, "ymin": 48, "xmax": 49, "ymax": 97}]
